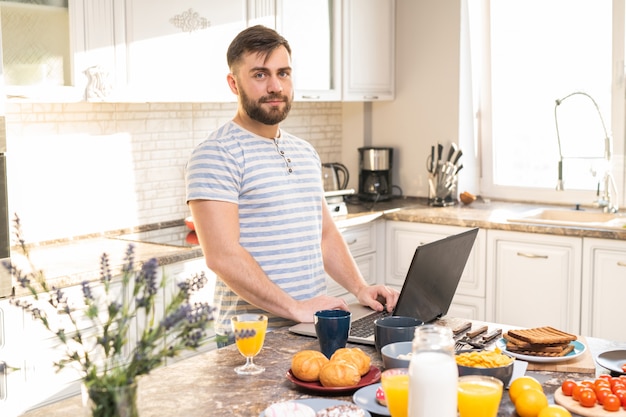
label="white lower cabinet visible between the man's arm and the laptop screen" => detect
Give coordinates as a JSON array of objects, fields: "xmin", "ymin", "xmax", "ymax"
[{"xmin": 326, "ymin": 221, "xmax": 384, "ymax": 303}]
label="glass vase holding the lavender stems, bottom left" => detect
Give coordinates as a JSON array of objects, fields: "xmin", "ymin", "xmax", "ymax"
[{"xmin": 82, "ymin": 382, "xmax": 139, "ymax": 417}]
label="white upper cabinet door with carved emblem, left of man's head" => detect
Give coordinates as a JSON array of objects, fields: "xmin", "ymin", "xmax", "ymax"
[{"xmin": 126, "ymin": 0, "xmax": 246, "ymax": 102}]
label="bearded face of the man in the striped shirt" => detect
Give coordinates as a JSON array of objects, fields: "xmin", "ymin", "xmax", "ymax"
[{"xmin": 230, "ymin": 47, "xmax": 293, "ymax": 125}]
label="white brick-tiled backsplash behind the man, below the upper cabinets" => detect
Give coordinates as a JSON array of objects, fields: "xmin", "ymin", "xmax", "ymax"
[{"xmin": 6, "ymin": 102, "xmax": 342, "ymax": 242}]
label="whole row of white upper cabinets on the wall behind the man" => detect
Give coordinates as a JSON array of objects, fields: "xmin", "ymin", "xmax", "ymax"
[{"xmin": 2, "ymin": 0, "xmax": 395, "ymax": 102}]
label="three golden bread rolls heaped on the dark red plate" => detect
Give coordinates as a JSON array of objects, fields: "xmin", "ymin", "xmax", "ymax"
[{"xmin": 291, "ymin": 348, "xmax": 371, "ymax": 387}]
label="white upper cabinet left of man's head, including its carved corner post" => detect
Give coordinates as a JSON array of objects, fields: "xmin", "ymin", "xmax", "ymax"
[{"xmin": 70, "ymin": 0, "xmax": 248, "ymax": 102}]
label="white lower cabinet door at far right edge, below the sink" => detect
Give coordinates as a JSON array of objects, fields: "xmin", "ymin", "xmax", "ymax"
[{"xmin": 581, "ymin": 238, "xmax": 626, "ymax": 342}]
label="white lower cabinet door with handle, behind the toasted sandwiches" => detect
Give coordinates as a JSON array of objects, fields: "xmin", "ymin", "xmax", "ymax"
[{"xmin": 487, "ymin": 230, "xmax": 582, "ymax": 334}]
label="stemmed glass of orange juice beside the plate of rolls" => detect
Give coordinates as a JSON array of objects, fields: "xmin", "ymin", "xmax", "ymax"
[{"xmin": 231, "ymin": 314, "xmax": 267, "ymax": 375}]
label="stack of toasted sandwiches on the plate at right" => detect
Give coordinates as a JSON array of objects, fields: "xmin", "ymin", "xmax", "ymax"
[{"xmin": 504, "ymin": 326, "xmax": 577, "ymax": 357}]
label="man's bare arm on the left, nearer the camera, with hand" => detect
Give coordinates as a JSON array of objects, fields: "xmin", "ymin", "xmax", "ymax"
[{"xmin": 189, "ymin": 200, "xmax": 347, "ymax": 322}]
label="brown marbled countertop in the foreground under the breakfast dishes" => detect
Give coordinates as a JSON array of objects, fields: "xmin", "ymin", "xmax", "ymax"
[{"xmin": 24, "ymin": 318, "xmax": 626, "ymax": 417}]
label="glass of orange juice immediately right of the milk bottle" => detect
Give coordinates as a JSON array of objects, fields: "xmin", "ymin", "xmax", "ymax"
[{"xmin": 458, "ymin": 375, "xmax": 503, "ymax": 417}]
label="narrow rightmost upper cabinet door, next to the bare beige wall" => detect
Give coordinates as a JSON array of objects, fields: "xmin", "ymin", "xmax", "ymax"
[{"xmin": 342, "ymin": 0, "xmax": 395, "ymax": 101}]
